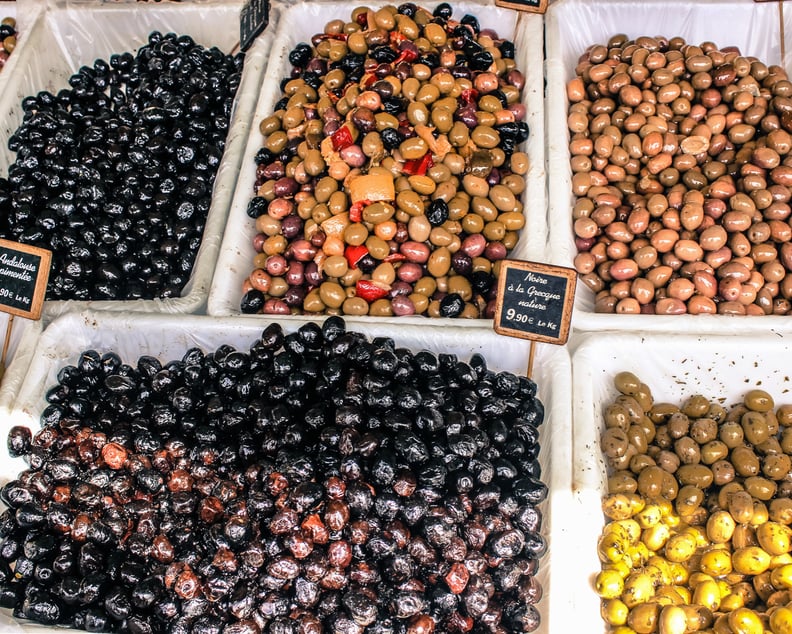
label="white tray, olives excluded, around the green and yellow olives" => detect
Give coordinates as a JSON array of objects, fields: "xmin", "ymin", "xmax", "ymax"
[{"xmin": 568, "ymin": 333, "xmax": 792, "ymax": 633}]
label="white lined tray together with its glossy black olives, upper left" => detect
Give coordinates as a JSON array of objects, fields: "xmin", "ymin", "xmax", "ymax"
[{"xmin": 0, "ymin": 2, "xmax": 276, "ymax": 316}]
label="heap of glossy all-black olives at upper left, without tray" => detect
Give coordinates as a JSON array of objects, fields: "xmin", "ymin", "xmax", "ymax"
[{"xmin": 0, "ymin": 32, "xmax": 243, "ymax": 300}]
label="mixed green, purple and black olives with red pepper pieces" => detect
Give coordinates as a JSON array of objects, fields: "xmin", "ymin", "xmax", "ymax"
[{"xmin": 241, "ymin": 3, "xmax": 529, "ymax": 318}]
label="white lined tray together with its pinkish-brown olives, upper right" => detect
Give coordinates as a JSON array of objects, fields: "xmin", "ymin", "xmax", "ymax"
[{"xmin": 547, "ymin": 1, "xmax": 789, "ymax": 332}]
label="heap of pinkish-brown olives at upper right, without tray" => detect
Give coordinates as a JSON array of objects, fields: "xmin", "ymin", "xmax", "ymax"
[{"xmin": 567, "ymin": 35, "xmax": 792, "ymax": 315}]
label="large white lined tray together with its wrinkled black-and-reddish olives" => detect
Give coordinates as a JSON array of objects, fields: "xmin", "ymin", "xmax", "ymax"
[{"xmin": 3, "ymin": 313, "xmax": 570, "ymax": 631}]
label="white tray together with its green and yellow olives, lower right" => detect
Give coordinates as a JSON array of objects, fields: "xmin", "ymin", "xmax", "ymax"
[{"xmin": 571, "ymin": 333, "xmax": 792, "ymax": 632}]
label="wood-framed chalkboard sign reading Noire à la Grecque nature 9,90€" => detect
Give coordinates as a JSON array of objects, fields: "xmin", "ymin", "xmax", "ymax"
[{"xmin": 494, "ymin": 260, "xmax": 577, "ymax": 344}]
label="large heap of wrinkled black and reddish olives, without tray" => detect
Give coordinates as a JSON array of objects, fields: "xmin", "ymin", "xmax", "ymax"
[{"xmin": 0, "ymin": 317, "xmax": 547, "ymax": 634}]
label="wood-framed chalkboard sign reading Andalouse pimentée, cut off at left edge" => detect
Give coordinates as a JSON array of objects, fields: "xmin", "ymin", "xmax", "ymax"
[{"xmin": 0, "ymin": 240, "xmax": 52, "ymax": 319}]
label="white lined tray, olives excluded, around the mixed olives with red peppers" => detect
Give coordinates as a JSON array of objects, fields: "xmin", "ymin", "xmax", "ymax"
[{"xmin": 207, "ymin": 0, "xmax": 547, "ymax": 327}]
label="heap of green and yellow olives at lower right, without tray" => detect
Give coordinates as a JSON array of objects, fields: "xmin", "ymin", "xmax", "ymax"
[{"xmin": 596, "ymin": 372, "xmax": 792, "ymax": 634}]
